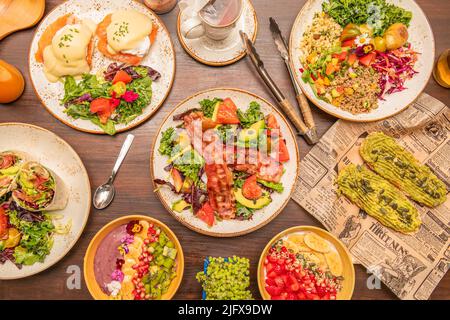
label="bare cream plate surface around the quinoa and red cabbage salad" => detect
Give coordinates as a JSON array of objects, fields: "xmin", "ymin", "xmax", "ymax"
[{"xmin": 289, "ymin": 0, "xmax": 434, "ymax": 122}]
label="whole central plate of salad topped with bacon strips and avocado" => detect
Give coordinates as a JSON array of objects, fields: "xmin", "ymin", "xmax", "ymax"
[{"xmin": 150, "ymin": 89, "xmax": 299, "ymax": 237}]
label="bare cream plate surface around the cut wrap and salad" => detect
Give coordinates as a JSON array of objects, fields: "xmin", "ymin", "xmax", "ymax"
[{"xmin": 0, "ymin": 123, "xmax": 91, "ymax": 280}]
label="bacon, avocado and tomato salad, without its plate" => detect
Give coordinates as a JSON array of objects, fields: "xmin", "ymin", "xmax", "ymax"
[{"xmin": 154, "ymin": 97, "xmax": 289, "ymax": 227}]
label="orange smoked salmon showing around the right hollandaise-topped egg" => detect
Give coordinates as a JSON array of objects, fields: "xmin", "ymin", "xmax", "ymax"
[{"xmin": 96, "ymin": 14, "xmax": 158, "ymax": 66}]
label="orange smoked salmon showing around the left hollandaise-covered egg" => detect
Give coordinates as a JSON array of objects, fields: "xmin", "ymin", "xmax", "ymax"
[{"xmin": 34, "ymin": 13, "xmax": 94, "ymax": 66}]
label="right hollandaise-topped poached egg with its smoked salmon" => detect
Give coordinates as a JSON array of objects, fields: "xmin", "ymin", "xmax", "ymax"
[{"xmin": 96, "ymin": 10, "xmax": 158, "ymax": 65}]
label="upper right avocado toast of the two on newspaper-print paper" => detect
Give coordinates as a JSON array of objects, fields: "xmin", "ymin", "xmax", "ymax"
[{"xmin": 360, "ymin": 132, "xmax": 447, "ymax": 207}]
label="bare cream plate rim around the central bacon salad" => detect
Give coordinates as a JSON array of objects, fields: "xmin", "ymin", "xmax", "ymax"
[{"xmin": 150, "ymin": 88, "xmax": 299, "ymax": 237}]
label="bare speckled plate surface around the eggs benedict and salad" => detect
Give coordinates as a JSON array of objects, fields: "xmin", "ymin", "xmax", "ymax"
[{"xmin": 29, "ymin": 0, "xmax": 175, "ymax": 134}]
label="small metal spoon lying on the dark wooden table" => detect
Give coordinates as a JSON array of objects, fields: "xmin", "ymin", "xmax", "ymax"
[{"xmin": 93, "ymin": 134, "xmax": 134, "ymax": 210}]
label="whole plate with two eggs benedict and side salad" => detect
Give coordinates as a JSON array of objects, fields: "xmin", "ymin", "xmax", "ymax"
[{"xmin": 29, "ymin": 0, "xmax": 175, "ymax": 135}]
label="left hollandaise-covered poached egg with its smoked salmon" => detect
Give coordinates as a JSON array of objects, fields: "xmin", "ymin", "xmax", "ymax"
[{"xmin": 35, "ymin": 14, "xmax": 96, "ymax": 82}]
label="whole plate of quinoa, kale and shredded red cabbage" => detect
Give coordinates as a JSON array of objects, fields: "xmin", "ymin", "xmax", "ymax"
[{"xmin": 290, "ymin": 0, "xmax": 434, "ymax": 122}]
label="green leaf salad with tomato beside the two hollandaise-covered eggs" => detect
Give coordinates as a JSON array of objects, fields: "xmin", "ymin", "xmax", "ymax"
[{"xmin": 61, "ymin": 63, "xmax": 161, "ymax": 135}]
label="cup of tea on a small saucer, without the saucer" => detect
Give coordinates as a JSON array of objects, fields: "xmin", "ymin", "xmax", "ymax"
[{"xmin": 181, "ymin": 0, "xmax": 243, "ymax": 41}]
